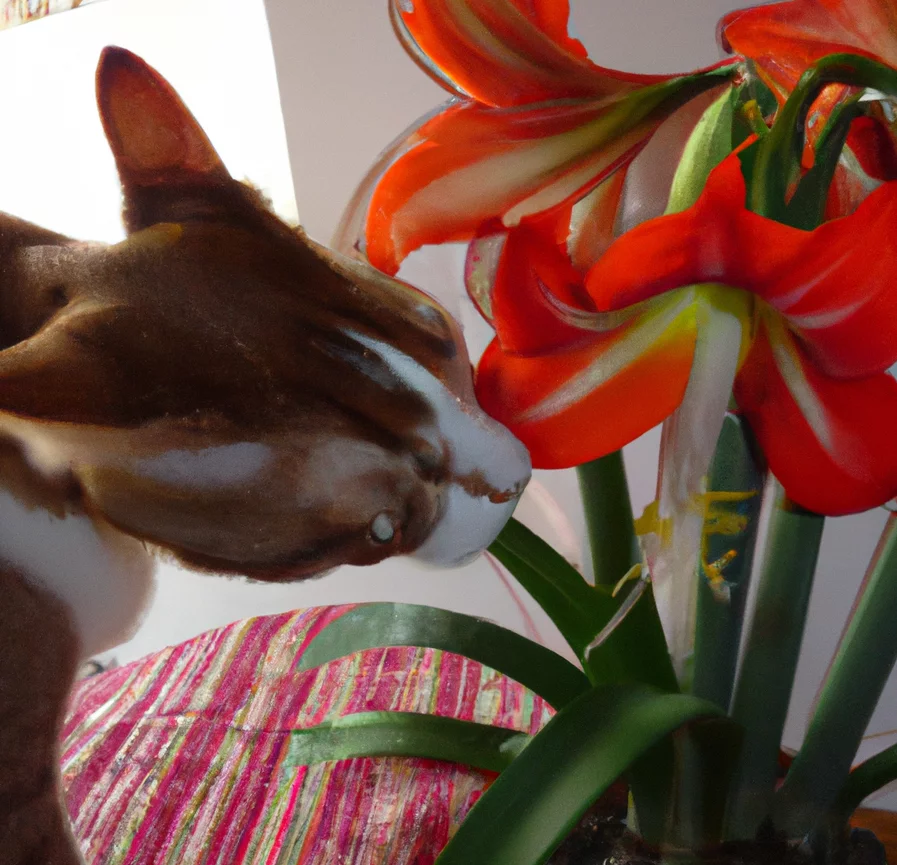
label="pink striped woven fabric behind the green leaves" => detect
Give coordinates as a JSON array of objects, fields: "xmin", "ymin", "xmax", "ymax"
[{"xmin": 63, "ymin": 607, "xmax": 551, "ymax": 865}]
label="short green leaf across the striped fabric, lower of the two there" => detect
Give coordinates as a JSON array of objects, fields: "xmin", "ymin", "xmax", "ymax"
[{"xmin": 282, "ymin": 712, "xmax": 532, "ymax": 772}]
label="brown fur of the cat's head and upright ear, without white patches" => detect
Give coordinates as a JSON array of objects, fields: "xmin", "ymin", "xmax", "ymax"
[{"xmin": 0, "ymin": 49, "xmax": 522, "ymax": 579}]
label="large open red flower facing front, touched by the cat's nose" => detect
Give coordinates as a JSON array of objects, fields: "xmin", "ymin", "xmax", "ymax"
[{"xmin": 477, "ymin": 156, "xmax": 897, "ymax": 514}]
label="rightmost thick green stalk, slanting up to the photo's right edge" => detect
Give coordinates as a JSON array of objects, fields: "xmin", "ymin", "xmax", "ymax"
[{"xmin": 773, "ymin": 516, "xmax": 897, "ymax": 838}]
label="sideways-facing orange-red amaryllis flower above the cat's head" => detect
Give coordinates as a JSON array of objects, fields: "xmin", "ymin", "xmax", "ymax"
[{"xmin": 366, "ymin": 0, "xmax": 735, "ymax": 272}]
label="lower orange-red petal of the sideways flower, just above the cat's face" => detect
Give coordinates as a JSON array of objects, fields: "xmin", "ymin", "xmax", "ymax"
[{"xmin": 367, "ymin": 96, "xmax": 665, "ymax": 273}]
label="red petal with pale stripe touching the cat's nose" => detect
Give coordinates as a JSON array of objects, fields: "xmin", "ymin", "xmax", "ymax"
[{"xmin": 476, "ymin": 305, "xmax": 696, "ymax": 468}]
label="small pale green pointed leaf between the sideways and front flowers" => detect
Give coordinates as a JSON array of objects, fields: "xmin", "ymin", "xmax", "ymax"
[{"xmin": 666, "ymin": 87, "xmax": 737, "ymax": 213}]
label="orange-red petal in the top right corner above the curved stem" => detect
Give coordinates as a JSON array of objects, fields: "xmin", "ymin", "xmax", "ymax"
[{"xmin": 720, "ymin": 0, "xmax": 897, "ymax": 92}]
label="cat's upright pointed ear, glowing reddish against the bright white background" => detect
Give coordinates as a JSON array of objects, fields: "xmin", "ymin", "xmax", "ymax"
[{"xmin": 97, "ymin": 46, "xmax": 235, "ymax": 231}]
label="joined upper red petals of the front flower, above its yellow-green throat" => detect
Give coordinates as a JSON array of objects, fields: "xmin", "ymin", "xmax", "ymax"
[{"xmin": 586, "ymin": 156, "xmax": 897, "ymax": 377}]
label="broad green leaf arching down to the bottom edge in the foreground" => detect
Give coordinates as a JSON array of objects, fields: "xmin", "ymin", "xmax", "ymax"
[{"xmin": 437, "ymin": 685, "xmax": 721, "ymax": 865}]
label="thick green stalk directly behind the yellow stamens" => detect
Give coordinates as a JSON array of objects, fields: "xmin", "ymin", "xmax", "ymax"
[{"xmin": 691, "ymin": 414, "xmax": 763, "ymax": 711}]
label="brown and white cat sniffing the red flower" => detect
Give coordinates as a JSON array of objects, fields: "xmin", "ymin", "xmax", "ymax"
[{"xmin": 0, "ymin": 47, "xmax": 530, "ymax": 865}]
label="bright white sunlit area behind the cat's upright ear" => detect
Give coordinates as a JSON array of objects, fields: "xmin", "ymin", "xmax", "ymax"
[{"xmin": 0, "ymin": 0, "xmax": 297, "ymax": 241}]
